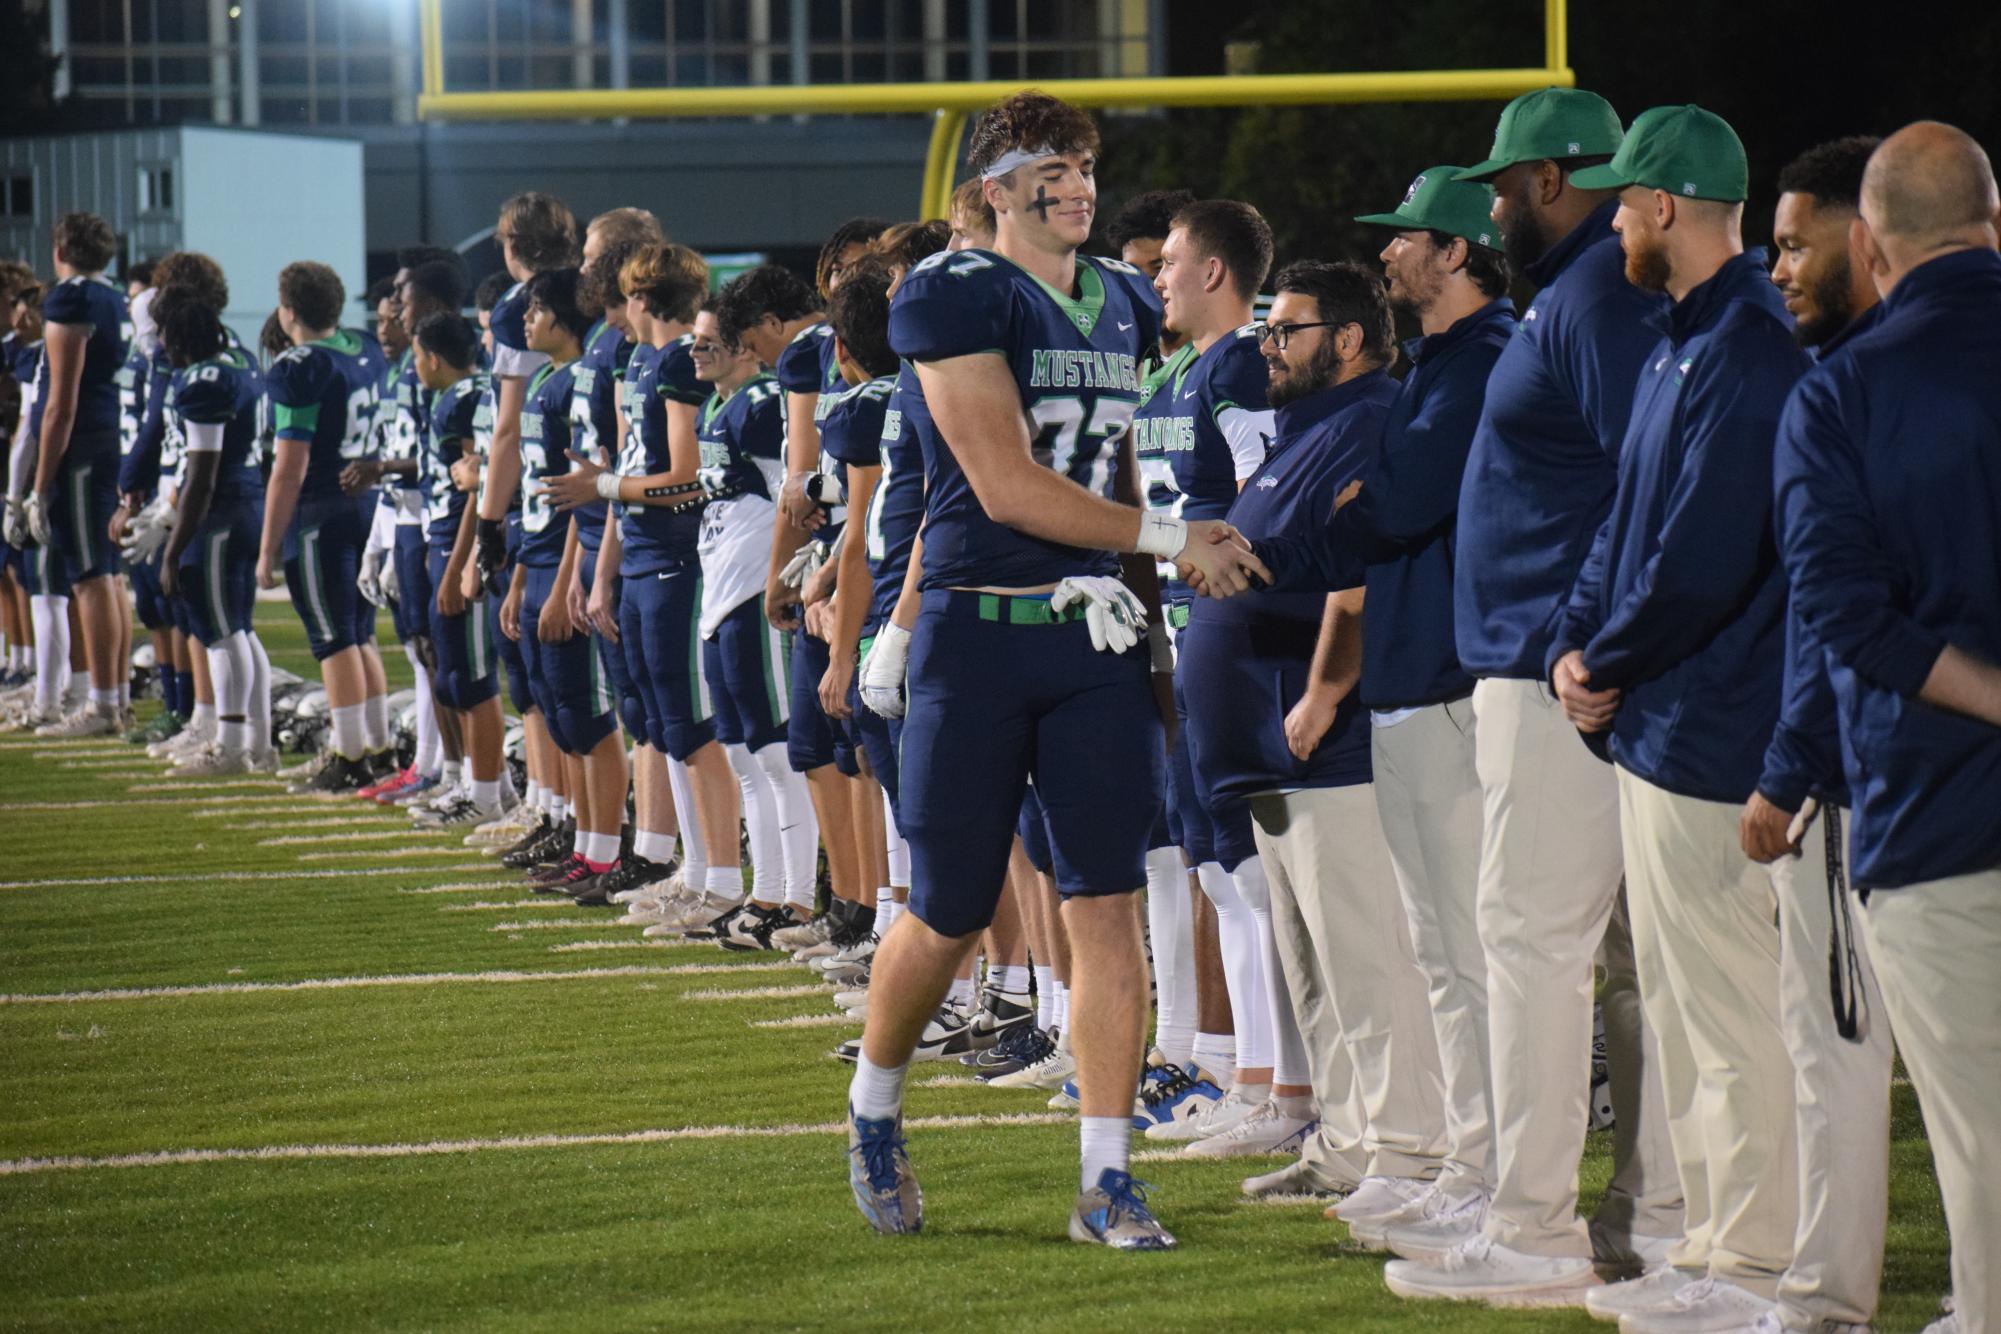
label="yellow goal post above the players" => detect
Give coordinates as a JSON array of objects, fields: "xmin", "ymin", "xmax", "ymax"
[{"xmin": 416, "ymin": 0, "xmax": 1577, "ymax": 218}]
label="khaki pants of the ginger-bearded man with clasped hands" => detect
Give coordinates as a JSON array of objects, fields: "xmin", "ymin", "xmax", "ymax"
[{"xmin": 1619, "ymin": 770, "xmax": 1799, "ymax": 1298}]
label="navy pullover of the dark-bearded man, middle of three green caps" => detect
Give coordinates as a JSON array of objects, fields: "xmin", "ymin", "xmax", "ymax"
[{"xmin": 1453, "ymin": 202, "xmax": 1667, "ymax": 680}]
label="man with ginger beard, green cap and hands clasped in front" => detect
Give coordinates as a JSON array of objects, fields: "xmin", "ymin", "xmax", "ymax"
[{"xmin": 1551, "ymin": 106, "xmax": 1807, "ymax": 1334}]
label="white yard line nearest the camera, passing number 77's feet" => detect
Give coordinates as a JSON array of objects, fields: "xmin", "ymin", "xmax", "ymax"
[{"xmin": 0, "ymin": 1112, "xmax": 1073, "ymax": 1176}]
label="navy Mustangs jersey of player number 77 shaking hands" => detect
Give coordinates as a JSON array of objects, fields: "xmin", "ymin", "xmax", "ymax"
[{"xmin": 890, "ymin": 250, "xmax": 1161, "ymax": 588}]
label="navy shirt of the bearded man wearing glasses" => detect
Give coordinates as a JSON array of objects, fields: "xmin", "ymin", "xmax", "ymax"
[{"xmin": 1177, "ymin": 370, "xmax": 1397, "ymax": 802}]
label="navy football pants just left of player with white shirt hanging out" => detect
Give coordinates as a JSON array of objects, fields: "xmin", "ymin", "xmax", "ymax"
[{"xmin": 618, "ymin": 560, "xmax": 716, "ymax": 760}]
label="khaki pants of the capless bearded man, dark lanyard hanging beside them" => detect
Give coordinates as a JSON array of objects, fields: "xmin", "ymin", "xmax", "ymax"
[{"xmin": 1773, "ymin": 810, "xmax": 1893, "ymax": 1330}]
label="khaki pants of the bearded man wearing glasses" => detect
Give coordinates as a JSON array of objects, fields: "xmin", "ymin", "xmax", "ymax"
[{"xmin": 1251, "ymin": 784, "xmax": 1445, "ymax": 1180}]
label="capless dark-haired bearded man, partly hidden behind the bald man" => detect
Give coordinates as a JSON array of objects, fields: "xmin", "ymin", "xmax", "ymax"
[{"xmin": 1739, "ymin": 136, "xmax": 1891, "ymax": 1334}]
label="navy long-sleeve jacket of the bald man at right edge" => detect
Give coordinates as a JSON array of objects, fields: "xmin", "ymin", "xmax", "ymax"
[{"xmin": 1775, "ymin": 250, "xmax": 2001, "ymax": 890}]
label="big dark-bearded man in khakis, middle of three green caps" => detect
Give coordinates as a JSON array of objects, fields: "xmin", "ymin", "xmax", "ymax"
[{"xmin": 1389, "ymin": 88, "xmax": 1681, "ymax": 1306}]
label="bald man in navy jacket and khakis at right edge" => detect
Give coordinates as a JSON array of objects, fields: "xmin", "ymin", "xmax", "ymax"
[{"xmin": 1777, "ymin": 122, "xmax": 2001, "ymax": 1334}]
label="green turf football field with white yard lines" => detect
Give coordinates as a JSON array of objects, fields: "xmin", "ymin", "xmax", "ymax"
[{"xmin": 0, "ymin": 602, "xmax": 1947, "ymax": 1332}]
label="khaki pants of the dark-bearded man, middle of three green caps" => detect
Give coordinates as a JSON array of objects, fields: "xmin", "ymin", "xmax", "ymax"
[{"xmin": 1473, "ymin": 680, "xmax": 1681, "ymax": 1258}]
